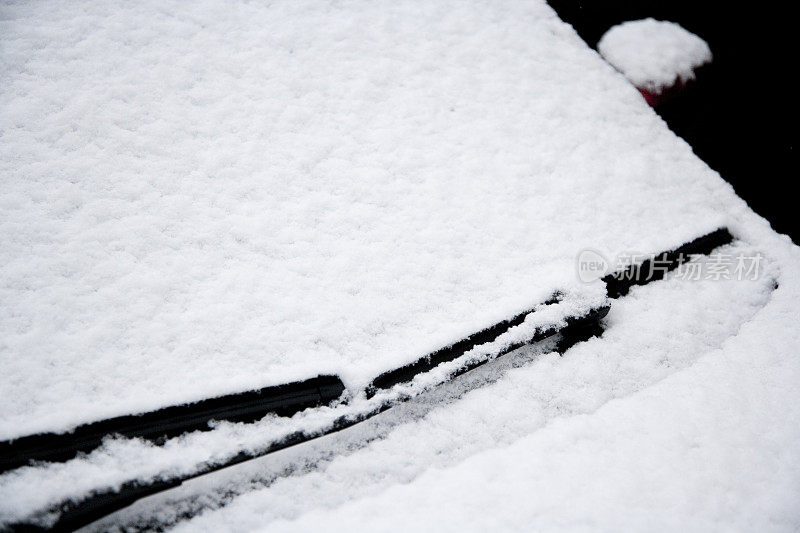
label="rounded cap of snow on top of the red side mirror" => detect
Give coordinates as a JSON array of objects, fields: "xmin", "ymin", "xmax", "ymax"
[{"xmin": 597, "ymin": 18, "xmax": 712, "ymax": 92}]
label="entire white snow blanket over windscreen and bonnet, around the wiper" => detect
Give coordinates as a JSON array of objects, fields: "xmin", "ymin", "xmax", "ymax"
[{"xmin": 0, "ymin": 0, "xmax": 800, "ymax": 531}]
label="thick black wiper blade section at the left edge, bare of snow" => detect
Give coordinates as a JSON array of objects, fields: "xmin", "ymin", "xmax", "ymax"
[{"xmin": 0, "ymin": 376, "xmax": 344, "ymax": 473}]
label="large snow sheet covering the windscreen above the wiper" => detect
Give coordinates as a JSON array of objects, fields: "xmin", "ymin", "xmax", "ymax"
[{"xmin": 0, "ymin": 0, "xmax": 729, "ymax": 439}]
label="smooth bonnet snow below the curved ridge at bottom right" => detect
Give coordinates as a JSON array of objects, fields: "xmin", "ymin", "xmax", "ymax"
[{"xmin": 268, "ymin": 268, "xmax": 800, "ymax": 531}]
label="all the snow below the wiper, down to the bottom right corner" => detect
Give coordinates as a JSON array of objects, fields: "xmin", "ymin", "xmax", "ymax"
[{"xmin": 104, "ymin": 238, "xmax": 800, "ymax": 531}]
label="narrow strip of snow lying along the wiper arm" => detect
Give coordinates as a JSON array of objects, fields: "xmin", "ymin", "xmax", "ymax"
[{"xmin": 0, "ymin": 284, "xmax": 608, "ymax": 525}]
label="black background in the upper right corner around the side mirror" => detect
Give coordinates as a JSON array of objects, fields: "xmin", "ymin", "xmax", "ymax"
[{"xmin": 549, "ymin": 0, "xmax": 800, "ymax": 243}]
